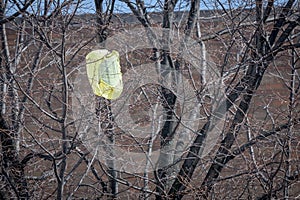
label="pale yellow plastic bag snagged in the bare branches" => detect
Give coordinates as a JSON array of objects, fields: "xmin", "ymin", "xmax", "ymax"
[{"xmin": 86, "ymin": 49, "xmax": 123, "ymax": 99}]
